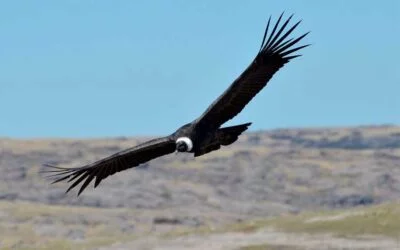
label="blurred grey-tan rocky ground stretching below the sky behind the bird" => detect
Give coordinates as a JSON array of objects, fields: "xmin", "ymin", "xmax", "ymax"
[{"xmin": 0, "ymin": 126, "xmax": 400, "ymax": 249}]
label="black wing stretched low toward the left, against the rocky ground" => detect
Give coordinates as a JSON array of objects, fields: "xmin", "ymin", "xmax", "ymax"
[{"xmin": 41, "ymin": 137, "xmax": 175, "ymax": 196}]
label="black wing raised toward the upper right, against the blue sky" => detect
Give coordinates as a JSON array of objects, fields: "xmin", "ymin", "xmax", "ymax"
[{"xmin": 196, "ymin": 13, "xmax": 309, "ymax": 129}]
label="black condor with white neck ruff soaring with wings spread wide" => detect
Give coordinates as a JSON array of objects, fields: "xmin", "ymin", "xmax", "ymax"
[{"xmin": 42, "ymin": 13, "xmax": 309, "ymax": 196}]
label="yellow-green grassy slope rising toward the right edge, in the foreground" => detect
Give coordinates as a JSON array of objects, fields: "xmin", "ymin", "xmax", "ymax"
[{"xmin": 163, "ymin": 200, "xmax": 400, "ymax": 239}]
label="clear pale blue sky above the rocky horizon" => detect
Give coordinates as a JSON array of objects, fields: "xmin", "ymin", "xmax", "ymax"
[{"xmin": 0, "ymin": 0, "xmax": 400, "ymax": 138}]
